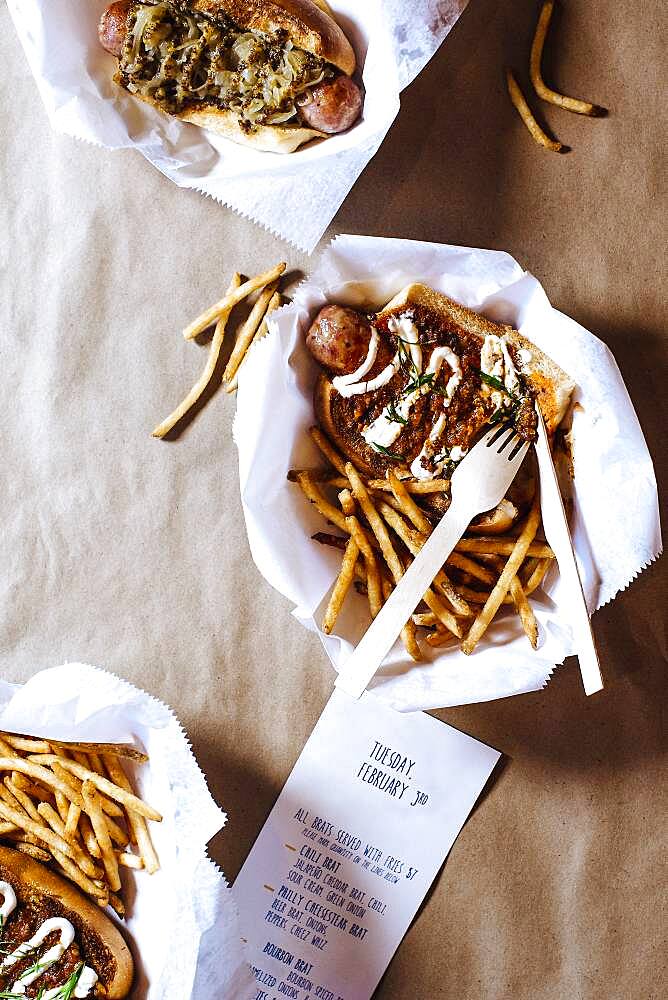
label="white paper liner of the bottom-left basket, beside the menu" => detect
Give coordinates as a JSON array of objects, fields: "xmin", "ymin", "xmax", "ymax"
[{"xmin": 0, "ymin": 663, "xmax": 252, "ymax": 1000}]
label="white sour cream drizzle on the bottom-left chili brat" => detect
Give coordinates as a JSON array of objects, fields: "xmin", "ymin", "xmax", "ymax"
[{"xmin": 0, "ymin": 881, "xmax": 97, "ymax": 1000}]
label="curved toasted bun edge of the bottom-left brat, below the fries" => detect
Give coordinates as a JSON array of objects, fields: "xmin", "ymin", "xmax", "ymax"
[{"xmin": 0, "ymin": 847, "xmax": 134, "ymax": 1000}]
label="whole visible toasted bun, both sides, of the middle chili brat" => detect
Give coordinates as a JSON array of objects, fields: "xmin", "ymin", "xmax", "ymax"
[{"xmin": 313, "ymin": 284, "xmax": 575, "ymax": 482}]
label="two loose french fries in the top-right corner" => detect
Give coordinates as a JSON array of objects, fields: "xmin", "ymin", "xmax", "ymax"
[{"xmin": 506, "ymin": 0, "xmax": 606, "ymax": 153}]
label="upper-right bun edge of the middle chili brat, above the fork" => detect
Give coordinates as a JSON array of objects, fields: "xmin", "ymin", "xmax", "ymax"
[{"xmin": 379, "ymin": 284, "xmax": 575, "ymax": 433}]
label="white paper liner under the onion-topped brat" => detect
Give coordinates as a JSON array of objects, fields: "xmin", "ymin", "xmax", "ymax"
[{"xmin": 8, "ymin": 0, "xmax": 468, "ymax": 253}]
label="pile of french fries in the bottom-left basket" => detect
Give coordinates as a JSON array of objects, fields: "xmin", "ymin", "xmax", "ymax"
[{"xmin": 0, "ymin": 733, "xmax": 162, "ymax": 917}]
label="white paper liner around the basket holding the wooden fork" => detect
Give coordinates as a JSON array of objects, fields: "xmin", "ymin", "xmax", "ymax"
[{"xmin": 235, "ymin": 236, "xmax": 661, "ymax": 710}]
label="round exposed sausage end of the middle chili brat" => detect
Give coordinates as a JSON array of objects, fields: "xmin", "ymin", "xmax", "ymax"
[{"xmin": 306, "ymin": 305, "xmax": 371, "ymax": 375}]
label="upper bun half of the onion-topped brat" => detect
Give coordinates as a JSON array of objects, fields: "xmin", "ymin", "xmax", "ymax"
[{"xmin": 190, "ymin": 0, "xmax": 355, "ymax": 76}]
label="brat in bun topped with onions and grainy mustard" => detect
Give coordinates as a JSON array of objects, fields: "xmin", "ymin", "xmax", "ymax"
[{"xmin": 98, "ymin": 0, "xmax": 362, "ymax": 153}]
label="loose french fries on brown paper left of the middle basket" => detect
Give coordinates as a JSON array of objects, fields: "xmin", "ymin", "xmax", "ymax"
[{"xmin": 152, "ymin": 263, "xmax": 286, "ymax": 438}]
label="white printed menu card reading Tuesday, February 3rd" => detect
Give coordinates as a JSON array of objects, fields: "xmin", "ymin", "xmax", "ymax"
[{"xmin": 234, "ymin": 690, "xmax": 500, "ymax": 1000}]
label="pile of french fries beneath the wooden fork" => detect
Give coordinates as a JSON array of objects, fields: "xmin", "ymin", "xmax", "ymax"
[{"xmin": 288, "ymin": 427, "xmax": 554, "ymax": 660}]
